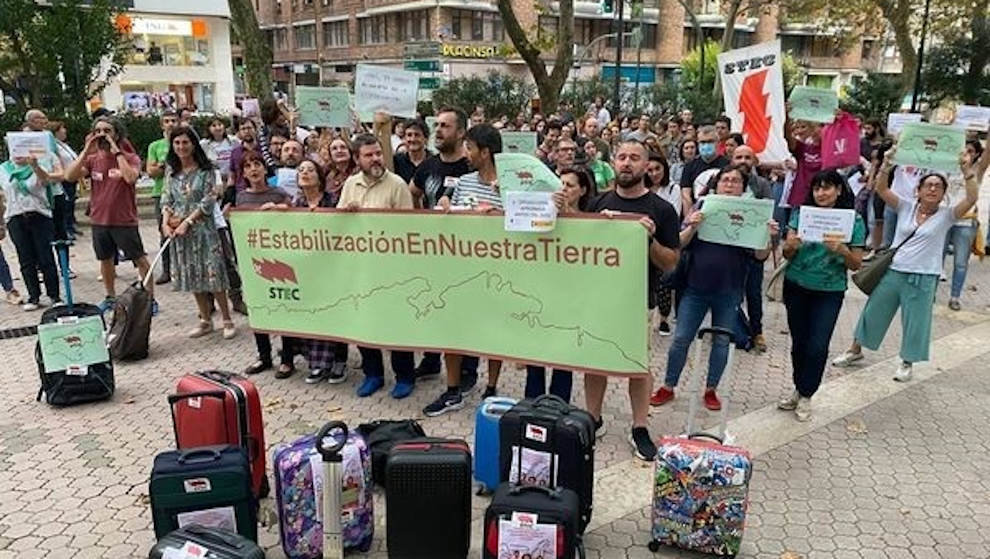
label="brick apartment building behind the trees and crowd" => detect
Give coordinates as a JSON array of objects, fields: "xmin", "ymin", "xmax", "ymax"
[{"xmin": 254, "ymin": 0, "xmax": 899, "ymax": 96}]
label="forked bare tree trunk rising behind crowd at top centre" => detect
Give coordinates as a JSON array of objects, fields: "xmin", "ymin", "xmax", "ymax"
[{"xmin": 498, "ymin": 0, "xmax": 574, "ymax": 114}]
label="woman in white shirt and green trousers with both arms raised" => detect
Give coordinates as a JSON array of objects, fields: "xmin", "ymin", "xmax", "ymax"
[{"xmin": 832, "ymin": 144, "xmax": 981, "ymax": 382}]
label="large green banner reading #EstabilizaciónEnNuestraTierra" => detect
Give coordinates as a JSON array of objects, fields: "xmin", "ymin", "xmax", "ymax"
[{"xmin": 231, "ymin": 210, "xmax": 648, "ymax": 375}]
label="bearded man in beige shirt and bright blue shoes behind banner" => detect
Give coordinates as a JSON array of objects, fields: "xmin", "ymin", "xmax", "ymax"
[{"xmin": 337, "ymin": 134, "xmax": 416, "ymax": 400}]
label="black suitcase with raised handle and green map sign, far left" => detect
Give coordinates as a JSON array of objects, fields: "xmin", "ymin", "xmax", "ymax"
[{"xmin": 34, "ymin": 241, "xmax": 115, "ymax": 406}]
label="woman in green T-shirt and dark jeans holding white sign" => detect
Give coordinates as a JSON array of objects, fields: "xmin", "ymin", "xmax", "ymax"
[{"xmin": 777, "ymin": 171, "xmax": 866, "ymax": 421}]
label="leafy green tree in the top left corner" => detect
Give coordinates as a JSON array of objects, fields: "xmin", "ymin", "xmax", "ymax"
[{"xmin": 0, "ymin": 0, "xmax": 130, "ymax": 115}]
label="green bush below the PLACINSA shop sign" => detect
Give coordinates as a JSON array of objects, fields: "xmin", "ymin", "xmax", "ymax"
[{"xmin": 433, "ymin": 70, "xmax": 535, "ymax": 118}]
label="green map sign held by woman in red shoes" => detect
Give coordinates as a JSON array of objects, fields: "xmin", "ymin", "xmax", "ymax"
[{"xmin": 698, "ymin": 194, "xmax": 773, "ymax": 250}]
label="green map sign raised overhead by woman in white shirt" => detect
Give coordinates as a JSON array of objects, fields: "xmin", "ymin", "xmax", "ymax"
[{"xmin": 894, "ymin": 122, "xmax": 966, "ymax": 173}]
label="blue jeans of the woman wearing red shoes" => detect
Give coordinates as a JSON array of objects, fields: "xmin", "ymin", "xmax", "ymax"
[{"xmin": 664, "ymin": 287, "xmax": 742, "ymax": 388}]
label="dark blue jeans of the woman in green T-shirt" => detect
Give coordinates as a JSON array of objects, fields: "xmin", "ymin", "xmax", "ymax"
[{"xmin": 784, "ymin": 279, "xmax": 845, "ymax": 398}]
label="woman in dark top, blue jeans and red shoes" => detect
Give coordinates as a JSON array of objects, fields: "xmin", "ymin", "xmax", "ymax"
[{"xmin": 650, "ymin": 165, "xmax": 778, "ymax": 411}]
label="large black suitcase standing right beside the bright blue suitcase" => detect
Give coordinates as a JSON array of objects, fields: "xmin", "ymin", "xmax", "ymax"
[{"xmin": 498, "ymin": 395, "xmax": 595, "ymax": 533}]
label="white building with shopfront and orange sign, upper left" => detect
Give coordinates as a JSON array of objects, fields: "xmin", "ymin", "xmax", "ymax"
[{"xmin": 102, "ymin": 0, "xmax": 234, "ymax": 112}]
